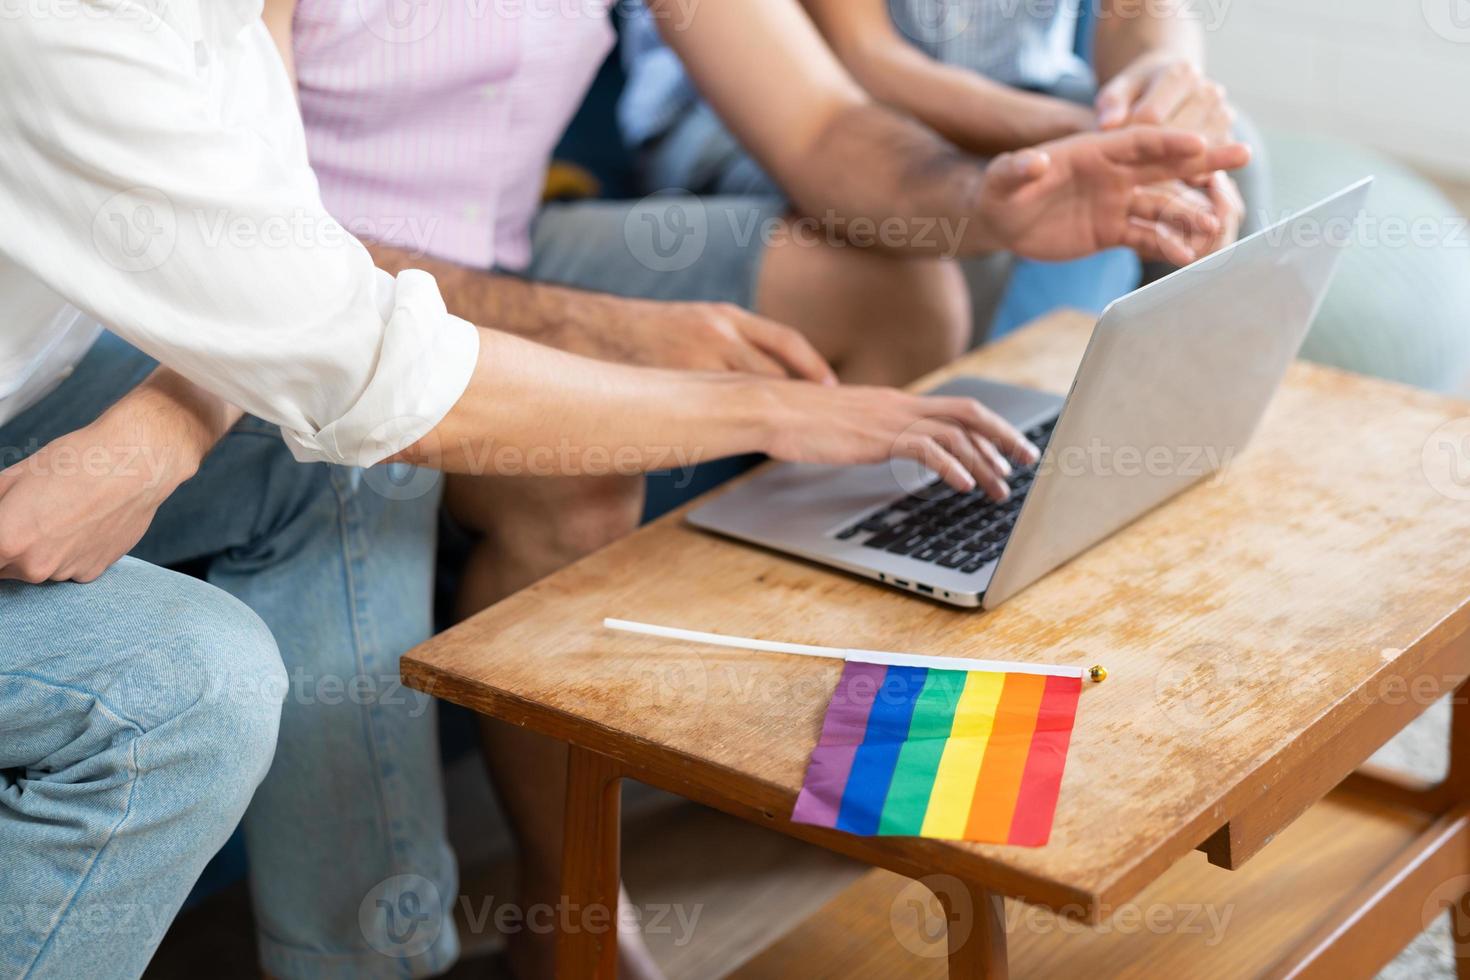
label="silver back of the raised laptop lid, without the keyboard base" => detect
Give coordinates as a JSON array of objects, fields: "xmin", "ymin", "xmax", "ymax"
[{"xmin": 985, "ymin": 178, "xmax": 1372, "ymax": 608}]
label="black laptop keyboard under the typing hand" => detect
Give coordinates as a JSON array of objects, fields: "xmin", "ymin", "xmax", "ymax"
[{"xmin": 836, "ymin": 419, "xmax": 1057, "ymax": 574}]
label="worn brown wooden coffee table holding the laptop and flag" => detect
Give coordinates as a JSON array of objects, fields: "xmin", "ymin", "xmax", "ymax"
[{"xmin": 403, "ymin": 314, "xmax": 1470, "ymax": 977}]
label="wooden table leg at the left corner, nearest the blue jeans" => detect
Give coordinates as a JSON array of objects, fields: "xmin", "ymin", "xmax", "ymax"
[{"xmin": 556, "ymin": 745, "xmax": 622, "ymax": 980}]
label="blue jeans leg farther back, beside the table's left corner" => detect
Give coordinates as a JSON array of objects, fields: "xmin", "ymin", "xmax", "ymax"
[{"xmin": 137, "ymin": 419, "xmax": 459, "ymax": 980}]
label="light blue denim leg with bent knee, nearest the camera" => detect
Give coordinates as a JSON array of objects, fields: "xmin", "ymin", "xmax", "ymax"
[{"xmin": 0, "ymin": 558, "xmax": 285, "ymax": 980}]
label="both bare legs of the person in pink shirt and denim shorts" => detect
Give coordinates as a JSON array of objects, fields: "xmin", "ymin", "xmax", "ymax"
[{"xmin": 445, "ymin": 241, "xmax": 970, "ymax": 980}]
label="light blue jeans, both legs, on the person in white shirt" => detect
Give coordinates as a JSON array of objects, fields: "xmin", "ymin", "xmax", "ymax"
[{"xmin": 0, "ymin": 335, "xmax": 459, "ymax": 980}]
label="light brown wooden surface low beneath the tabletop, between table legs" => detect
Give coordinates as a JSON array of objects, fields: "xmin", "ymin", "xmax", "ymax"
[{"xmin": 729, "ymin": 798, "xmax": 1429, "ymax": 980}]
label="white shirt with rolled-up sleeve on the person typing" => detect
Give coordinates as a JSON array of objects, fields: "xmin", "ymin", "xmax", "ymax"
[{"xmin": 0, "ymin": 0, "xmax": 479, "ymax": 466}]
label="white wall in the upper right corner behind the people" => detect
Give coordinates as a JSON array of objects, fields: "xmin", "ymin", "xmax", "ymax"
[{"xmin": 1197, "ymin": 0, "xmax": 1470, "ymax": 181}]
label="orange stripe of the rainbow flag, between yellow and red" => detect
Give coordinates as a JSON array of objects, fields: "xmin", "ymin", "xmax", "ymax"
[{"xmin": 964, "ymin": 674, "xmax": 1047, "ymax": 843}]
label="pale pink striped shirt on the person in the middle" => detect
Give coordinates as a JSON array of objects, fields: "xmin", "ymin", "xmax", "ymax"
[{"xmin": 294, "ymin": 0, "xmax": 613, "ymax": 269}]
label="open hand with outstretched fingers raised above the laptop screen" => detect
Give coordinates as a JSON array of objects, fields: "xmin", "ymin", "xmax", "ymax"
[{"xmin": 980, "ymin": 126, "xmax": 1251, "ymax": 266}]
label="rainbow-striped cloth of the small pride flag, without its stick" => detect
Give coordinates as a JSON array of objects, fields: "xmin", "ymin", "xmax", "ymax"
[{"xmin": 791, "ymin": 660, "xmax": 1082, "ymax": 848}]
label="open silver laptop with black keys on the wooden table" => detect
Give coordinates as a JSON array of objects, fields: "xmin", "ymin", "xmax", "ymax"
[{"xmin": 688, "ymin": 178, "xmax": 1372, "ymax": 608}]
